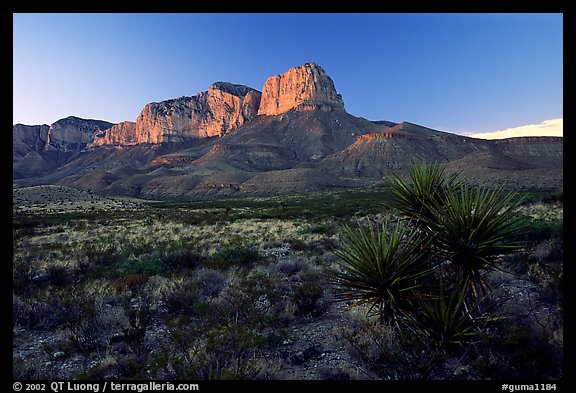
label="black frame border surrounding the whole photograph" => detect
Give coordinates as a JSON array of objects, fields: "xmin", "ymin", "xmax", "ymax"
[{"xmin": 7, "ymin": 0, "xmax": 576, "ymax": 393}]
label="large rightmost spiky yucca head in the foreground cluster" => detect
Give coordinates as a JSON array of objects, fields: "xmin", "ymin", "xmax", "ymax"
[{"xmin": 424, "ymin": 183, "xmax": 524, "ymax": 297}]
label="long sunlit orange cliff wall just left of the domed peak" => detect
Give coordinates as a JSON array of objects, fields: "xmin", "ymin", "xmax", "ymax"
[{"xmin": 135, "ymin": 82, "xmax": 260, "ymax": 143}]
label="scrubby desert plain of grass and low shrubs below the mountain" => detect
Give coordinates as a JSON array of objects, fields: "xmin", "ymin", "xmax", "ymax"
[{"xmin": 12, "ymin": 178, "xmax": 563, "ymax": 380}]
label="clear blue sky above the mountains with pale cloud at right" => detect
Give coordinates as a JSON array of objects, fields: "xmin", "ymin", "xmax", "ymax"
[{"xmin": 13, "ymin": 13, "xmax": 563, "ymax": 138}]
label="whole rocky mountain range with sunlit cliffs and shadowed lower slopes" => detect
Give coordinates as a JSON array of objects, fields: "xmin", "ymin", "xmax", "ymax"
[{"xmin": 13, "ymin": 63, "xmax": 563, "ymax": 199}]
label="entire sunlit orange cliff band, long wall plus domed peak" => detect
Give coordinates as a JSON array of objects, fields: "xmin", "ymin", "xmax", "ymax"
[{"xmin": 85, "ymin": 63, "xmax": 344, "ymax": 147}]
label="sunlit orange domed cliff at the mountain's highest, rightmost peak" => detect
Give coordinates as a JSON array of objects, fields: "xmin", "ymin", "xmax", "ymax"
[{"xmin": 258, "ymin": 63, "xmax": 344, "ymax": 116}]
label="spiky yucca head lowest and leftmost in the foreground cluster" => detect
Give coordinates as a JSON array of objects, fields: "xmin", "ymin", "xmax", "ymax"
[{"xmin": 331, "ymin": 221, "xmax": 432, "ymax": 324}]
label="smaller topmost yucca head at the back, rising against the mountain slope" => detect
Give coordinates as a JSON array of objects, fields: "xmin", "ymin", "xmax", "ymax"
[{"xmin": 386, "ymin": 161, "xmax": 457, "ymax": 224}]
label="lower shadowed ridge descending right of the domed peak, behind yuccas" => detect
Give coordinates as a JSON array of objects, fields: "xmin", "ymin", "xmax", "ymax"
[{"xmin": 319, "ymin": 122, "xmax": 563, "ymax": 188}]
